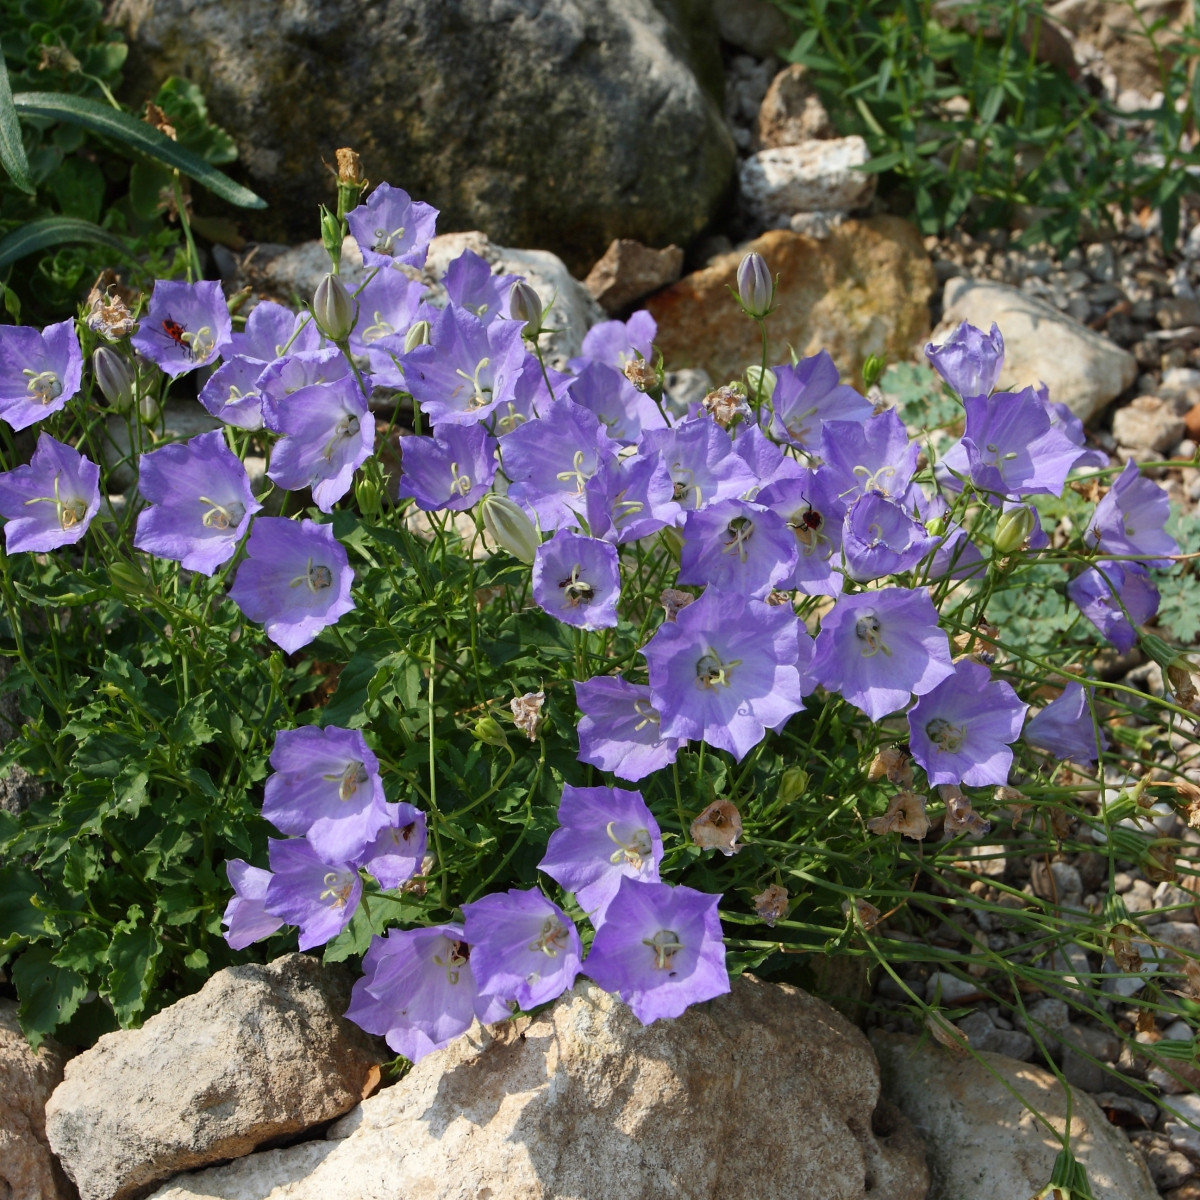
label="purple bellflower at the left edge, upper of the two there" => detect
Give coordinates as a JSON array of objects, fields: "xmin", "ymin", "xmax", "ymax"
[{"xmin": 0, "ymin": 320, "xmax": 83, "ymax": 430}]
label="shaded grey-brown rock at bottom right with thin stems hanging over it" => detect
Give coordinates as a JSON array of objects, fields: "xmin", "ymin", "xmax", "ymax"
[{"xmin": 871, "ymin": 1033, "xmax": 1158, "ymax": 1200}]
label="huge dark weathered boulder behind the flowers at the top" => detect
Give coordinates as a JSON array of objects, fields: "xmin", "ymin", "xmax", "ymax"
[{"xmin": 108, "ymin": 0, "xmax": 734, "ymax": 271}]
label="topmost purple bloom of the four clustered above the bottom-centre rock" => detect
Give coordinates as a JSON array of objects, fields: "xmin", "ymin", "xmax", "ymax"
[{"xmin": 538, "ymin": 784, "xmax": 662, "ymax": 925}]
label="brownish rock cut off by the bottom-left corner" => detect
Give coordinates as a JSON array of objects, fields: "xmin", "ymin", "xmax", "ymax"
[{"xmin": 0, "ymin": 1000, "xmax": 73, "ymax": 1200}]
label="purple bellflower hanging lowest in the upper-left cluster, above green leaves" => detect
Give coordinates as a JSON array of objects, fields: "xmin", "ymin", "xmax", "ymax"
[{"xmin": 229, "ymin": 517, "xmax": 354, "ymax": 654}]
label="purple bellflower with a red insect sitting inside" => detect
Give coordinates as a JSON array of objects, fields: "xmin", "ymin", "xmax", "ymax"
[{"xmin": 130, "ymin": 280, "xmax": 233, "ymax": 379}]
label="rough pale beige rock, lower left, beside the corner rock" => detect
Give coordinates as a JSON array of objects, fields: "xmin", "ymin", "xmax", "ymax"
[{"xmin": 46, "ymin": 954, "xmax": 382, "ymax": 1200}]
